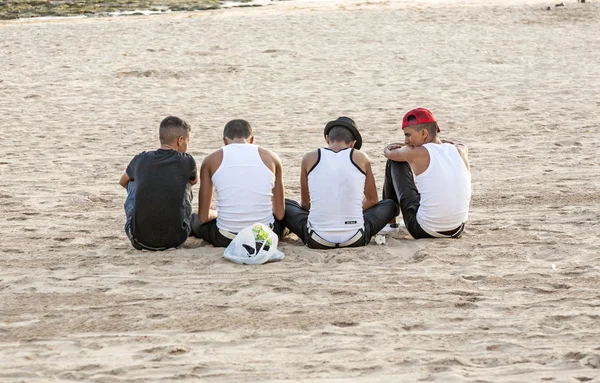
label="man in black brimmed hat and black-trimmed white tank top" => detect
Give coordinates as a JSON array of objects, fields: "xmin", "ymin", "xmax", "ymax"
[{"xmin": 284, "ymin": 117, "xmax": 398, "ymax": 249}]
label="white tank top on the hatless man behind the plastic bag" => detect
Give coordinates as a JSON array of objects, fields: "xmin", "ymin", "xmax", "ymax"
[{"xmin": 212, "ymin": 144, "xmax": 275, "ymax": 233}]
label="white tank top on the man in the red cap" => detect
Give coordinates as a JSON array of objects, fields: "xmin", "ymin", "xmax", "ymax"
[{"xmin": 415, "ymin": 143, "xmax": 471, "ymax": 232}]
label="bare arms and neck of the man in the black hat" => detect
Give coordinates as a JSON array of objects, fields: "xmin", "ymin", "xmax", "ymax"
[{"xmin": 300, "ymin": 136, "xmax": 378, "ymax": 211}]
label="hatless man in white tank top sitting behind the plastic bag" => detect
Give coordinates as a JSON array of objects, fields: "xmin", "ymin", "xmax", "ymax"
[{"xmin": 192, "ymin": 120, "xmax": 285, "ymax": 247}]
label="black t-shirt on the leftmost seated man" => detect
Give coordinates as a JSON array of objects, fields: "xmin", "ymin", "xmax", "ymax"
[{"xmin": 126, "ymin": 149, "xmax": 196, "ymax": 248}]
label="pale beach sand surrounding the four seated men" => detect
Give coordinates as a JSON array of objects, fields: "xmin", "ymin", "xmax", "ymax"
[{"xmin": 0, "ymin": 1, "xmax": 600, "ymax": 382}]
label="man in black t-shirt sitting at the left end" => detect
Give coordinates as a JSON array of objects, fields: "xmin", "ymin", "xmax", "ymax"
[{"xmin": 119, "ymin": 116, "xmax": 199, "ymax": 251}]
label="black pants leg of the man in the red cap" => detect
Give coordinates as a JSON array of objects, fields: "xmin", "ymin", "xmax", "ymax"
[{"xmin": 383, "ymin": 160, "xmax": 440, "ymax": 239}]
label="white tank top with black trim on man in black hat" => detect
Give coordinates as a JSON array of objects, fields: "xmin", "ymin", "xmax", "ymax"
[{"xmin": 308, "ymin": 148, "xmax": 366, "ymax": 243}]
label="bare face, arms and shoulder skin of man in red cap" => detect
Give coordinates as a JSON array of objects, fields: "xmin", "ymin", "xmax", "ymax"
[{"xmin": 383, "ymin": 125, "xmax": 470, "ymax": 176}]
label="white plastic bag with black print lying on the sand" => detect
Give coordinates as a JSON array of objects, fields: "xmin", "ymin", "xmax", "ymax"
[{"xmin": 223, "ymin": 223, "xmax": 285, "ymax": 265}]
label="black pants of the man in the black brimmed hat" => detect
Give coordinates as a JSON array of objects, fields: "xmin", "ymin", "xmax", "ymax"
[{"xmin": 283, "ymin": 199, "xmax": 398, "ymax": 249}]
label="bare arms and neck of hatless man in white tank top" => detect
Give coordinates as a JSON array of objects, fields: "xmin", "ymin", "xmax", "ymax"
[{"xmin": 198, "ymin": 136, "xmax": 285, "ymax": 223}]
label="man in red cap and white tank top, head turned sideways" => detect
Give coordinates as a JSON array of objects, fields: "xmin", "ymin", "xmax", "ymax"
[{"xmin": 383, "ymin": 108, "xmax": 471, "ymax": 238}]
